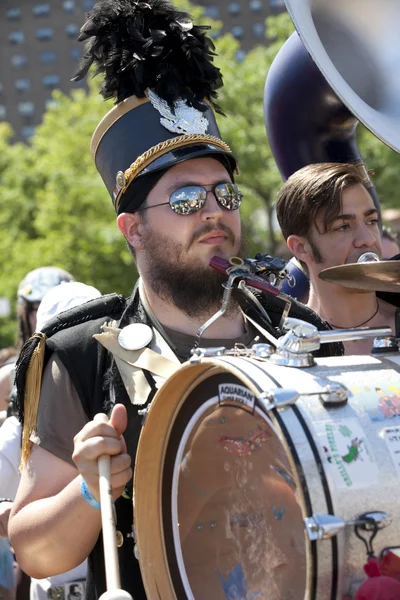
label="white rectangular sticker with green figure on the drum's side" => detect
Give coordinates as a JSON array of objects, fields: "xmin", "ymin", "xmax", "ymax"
[{"xmin": 315, "ymin": 419, "xmax": 379, "ymax": 488}]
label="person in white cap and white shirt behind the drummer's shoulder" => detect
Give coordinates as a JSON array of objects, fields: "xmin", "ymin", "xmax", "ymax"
[{"xmin": 0, "ymin": 281, "xmax": 101, "ymax": 600}]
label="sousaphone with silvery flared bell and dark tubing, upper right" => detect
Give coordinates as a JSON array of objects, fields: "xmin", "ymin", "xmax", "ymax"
[{"xmin": 264, "ymin": 0, "xmax": 400, "ymax": 296}]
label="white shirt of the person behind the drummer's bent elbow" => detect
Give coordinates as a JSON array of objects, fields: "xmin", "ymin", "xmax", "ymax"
[{"xmin": 0, "ymin": 417, "xmax": 87, "ymax": 600}]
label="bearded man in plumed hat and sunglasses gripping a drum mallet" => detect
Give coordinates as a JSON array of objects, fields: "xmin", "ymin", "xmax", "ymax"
[{"xmin": 10, "ymin": 0, "xmax": 340, "ymax": 600}]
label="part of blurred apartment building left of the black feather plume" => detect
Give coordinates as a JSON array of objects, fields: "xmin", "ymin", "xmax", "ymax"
[{"xmin": 0, "ymin": 0, "xmax": 94, "ymax": 140}]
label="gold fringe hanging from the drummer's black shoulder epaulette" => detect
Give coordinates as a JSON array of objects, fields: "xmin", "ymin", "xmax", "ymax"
[{"xmin": 20, "ymin": 333, "xmax": 46, "ymax": 469}]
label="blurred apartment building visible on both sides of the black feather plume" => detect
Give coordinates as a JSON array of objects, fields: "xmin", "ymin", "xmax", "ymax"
[{"xmin": 0, "ymin": 0, "xmax": 284, "ymax": 141}]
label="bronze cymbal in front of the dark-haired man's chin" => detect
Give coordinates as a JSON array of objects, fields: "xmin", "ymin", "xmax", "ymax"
[{"xmin": 319, "ymin": 260, "xmax": 400, "ymax": 293}]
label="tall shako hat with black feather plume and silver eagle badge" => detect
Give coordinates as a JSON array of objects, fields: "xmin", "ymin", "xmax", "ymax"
[{"xmin": 74, "ymin": 0, "xmax": 236, "ymax": 213}]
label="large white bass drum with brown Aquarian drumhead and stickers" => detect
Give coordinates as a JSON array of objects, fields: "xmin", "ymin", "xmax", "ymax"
[{"xmin": 134, "ymin": 356, "xmax": 400, "ymax": 600}]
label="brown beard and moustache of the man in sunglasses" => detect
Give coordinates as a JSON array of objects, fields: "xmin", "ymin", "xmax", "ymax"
[{"xmin": 145, "ymin": 225, "xmax": 245, "ymax": 317}]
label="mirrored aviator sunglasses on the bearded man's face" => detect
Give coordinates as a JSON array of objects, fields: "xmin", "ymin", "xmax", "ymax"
[{"xmin": 137, "ymin": 183, "xmax": 243, "ymax": 215}]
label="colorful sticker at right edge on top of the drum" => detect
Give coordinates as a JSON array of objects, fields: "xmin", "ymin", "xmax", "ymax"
[{"xmin": 350, "ymin": 384, "xmax": 400, "ymax": 421}]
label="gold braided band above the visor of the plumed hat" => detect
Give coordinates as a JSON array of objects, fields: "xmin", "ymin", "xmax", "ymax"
[{"xmin": 115, "ymin": 133, "xmax": 232, "ymax": 212}]
